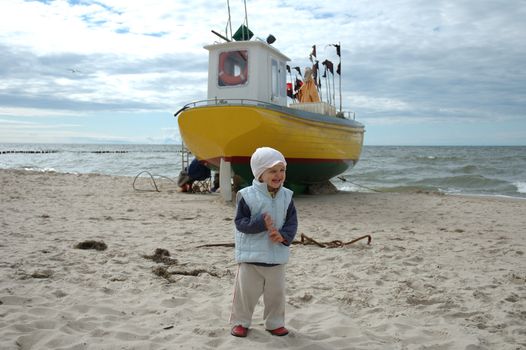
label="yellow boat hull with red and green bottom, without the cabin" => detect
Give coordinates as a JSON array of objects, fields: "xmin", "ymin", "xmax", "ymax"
[{"xmin": 178, "ymin": 105, "xmax": 364, "ymax": 185}]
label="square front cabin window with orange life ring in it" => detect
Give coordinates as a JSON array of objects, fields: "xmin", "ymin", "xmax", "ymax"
[{"xmin": 217, "ymin": 50, "xmax": 248, "ymax": 86}]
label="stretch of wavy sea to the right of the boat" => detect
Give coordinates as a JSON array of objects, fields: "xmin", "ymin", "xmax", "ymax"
[{"xmin": 337, "ymin": 146, "xmax": 526, "ymax": 198}]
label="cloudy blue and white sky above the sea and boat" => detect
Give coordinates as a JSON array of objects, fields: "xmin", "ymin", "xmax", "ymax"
[{"xmin": 0, "ymin": 0, "xmax": 526, "ymax": 145}]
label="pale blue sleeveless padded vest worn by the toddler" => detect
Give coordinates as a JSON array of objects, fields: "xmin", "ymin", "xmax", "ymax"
[{"xmin": 234, "ymin": 179, "xmax": 293, "ymax": 264}]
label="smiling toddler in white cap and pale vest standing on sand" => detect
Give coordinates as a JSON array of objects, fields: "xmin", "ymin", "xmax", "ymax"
[{"xmin": 230, "ymin": 147, "xmax": 298, "ymax": 337}]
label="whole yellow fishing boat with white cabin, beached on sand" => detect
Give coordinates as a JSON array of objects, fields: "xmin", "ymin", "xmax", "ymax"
[{"xmin": 175, "ymin": 26, "xmax": 364, "ymax": 196}]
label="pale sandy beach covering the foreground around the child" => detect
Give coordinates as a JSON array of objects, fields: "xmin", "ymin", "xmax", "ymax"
[{"xmin": 0, "ymin": 170, "xmax": 526, "ymax": 350}]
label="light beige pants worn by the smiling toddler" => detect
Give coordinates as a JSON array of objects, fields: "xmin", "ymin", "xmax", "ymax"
[{"xmin": 230, "ymin": 263, "xmax": 285, "ymax": 330}]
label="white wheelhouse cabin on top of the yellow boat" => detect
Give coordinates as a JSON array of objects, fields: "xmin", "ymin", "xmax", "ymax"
[{"xmin": 205, "ymin": 40, "xmax": 290, "ymax": 106}]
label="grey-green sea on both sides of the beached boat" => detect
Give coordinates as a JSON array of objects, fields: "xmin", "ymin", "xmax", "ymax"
[{"xmin": 0, "ymin": 144, "xmax": 526, "ymax": 198}]
